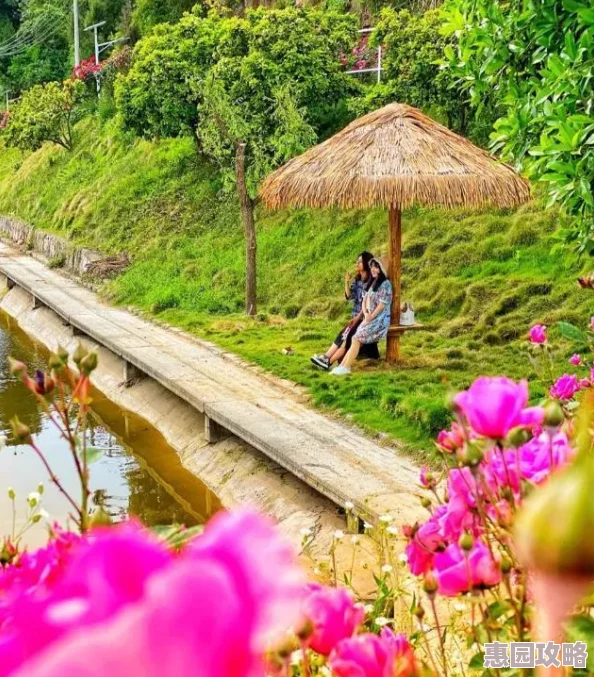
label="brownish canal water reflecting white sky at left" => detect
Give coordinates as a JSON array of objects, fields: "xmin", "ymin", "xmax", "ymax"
[{"xmin": 0, "ymin": 311, "xmax": 219, "ymax": 545}]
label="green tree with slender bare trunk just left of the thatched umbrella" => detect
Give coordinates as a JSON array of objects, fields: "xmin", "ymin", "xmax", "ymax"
[{"xmin": 198, "ymin": 8, "xmax": 355, "ymax": 315}]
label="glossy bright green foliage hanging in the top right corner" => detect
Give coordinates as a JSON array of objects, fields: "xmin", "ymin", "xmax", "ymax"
[{"xmin": 444, "ymin": 0, "xmax": 594, "ymax": 254}]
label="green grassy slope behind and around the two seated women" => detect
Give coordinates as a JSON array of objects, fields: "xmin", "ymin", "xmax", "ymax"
[{"xmin": 0, "ymin": 119, "xmax": 592, "ymax": 462}]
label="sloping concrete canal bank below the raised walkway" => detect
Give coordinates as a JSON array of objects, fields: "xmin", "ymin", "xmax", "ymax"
[{"xmin": 0, "ymin": 282, "xmax": 344, "ymax": 558}]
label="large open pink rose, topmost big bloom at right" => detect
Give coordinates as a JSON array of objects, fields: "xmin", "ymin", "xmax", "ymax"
[{"xmin": 454, "ymin": 376, "xmax": 544, "ymax": 439}]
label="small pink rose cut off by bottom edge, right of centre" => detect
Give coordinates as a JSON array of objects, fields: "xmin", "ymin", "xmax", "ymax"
[{"xmin": 329, "ymin": 633, "xmax": 396, "ymax": 677}]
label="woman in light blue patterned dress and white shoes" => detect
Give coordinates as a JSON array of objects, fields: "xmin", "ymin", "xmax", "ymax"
[{"xmin": 331, "ymin": 259, "xmax": 392, "ymax": 376}]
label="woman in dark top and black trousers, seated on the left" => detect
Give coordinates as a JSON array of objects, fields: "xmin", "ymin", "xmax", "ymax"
[{"xmin": 310, "ymin": 252, "xmax": 373, "ymax": 370}]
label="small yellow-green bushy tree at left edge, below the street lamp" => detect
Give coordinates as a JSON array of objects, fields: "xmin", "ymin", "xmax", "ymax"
[{"xmin": 3, "ymin": 80, "xmax": 84, "ymax": 151}]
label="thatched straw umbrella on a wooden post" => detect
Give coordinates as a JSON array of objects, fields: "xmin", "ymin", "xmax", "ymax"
[{"xmin": 260, "ymin": 103, "xmax": 530, "ymax": 362}]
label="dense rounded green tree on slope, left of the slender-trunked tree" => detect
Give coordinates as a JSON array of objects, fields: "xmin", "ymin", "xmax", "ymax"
[{"xmin": 115, "ymin": 13, "xmax": 221, "ymax": 143}]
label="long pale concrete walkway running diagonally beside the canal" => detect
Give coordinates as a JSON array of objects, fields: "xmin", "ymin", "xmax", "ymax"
[{"xmin": 0, "ymin": 243, "xmax": 419, "ymax": 524}]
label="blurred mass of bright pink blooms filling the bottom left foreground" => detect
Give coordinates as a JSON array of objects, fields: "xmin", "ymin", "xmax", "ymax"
[{"xmin": 0, "ymin": 510, "xmax": 304, "ymax": 677}]
